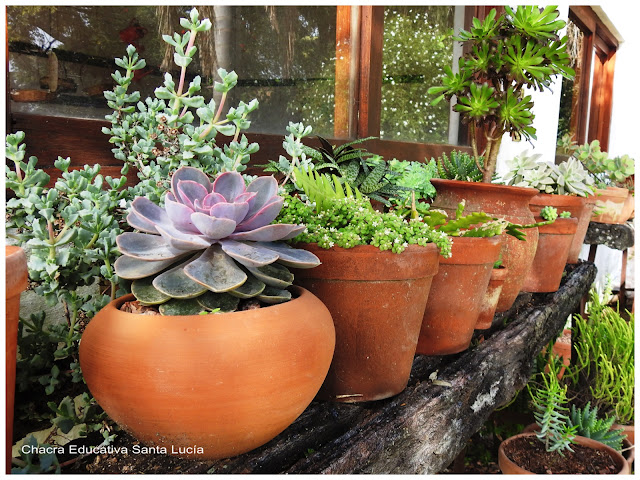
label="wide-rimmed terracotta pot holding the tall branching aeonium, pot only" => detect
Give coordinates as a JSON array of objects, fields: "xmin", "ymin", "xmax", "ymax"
[{"xmin": 431, "ymin": 179, "xmax": 538, "ymax": 312}]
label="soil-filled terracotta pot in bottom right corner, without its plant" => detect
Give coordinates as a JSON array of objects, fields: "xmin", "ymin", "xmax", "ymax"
[{"xmin": 498, "ymin": 433, "xmax": 629, "ymax": 474}]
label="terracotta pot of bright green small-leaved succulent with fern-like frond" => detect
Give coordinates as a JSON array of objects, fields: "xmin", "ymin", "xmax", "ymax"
[{"xmin": 278, "ymin": 169, "xmax": 451, "ymax": 402}]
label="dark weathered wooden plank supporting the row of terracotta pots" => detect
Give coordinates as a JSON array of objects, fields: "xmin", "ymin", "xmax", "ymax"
[{"xmin": 80, "ymin": 262, "xmax": 596, "ymax": 474}]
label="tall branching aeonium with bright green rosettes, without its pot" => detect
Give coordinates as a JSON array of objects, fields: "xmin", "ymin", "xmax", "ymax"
[{"xmin": 428, "ymin": 6, "xmax": 574, "ymax": 183}]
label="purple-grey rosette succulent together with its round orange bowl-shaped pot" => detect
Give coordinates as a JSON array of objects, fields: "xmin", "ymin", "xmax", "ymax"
[{"xmin": 80, "ymin": 167, "xmax": 335, "ymax": 458}]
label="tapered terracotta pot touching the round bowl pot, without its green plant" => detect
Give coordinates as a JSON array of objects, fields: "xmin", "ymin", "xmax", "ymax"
[{"xmin": 295, "ymin": 244, "xmax": 440, "ymax": 402}]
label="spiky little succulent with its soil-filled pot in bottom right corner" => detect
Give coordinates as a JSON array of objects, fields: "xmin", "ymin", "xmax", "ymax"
[{"xmin": 498, "ymin": 362, "xmax": 630, "ymax": 474}]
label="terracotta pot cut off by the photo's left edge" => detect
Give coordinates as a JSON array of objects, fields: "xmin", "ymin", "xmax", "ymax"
[{"xmin": 5, "ymin": 247, "xmax": 29, "ymax": 473}]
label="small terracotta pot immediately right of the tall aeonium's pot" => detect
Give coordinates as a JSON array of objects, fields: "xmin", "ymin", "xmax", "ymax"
[{"xmin": 522, "ymin": 217, "xmax": 578, "ymax": 292}]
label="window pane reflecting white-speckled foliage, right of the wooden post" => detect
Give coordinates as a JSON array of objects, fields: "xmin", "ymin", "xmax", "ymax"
[{"xmin": 381, "ymin": 6, "xmax": 464, "ymax": 143}]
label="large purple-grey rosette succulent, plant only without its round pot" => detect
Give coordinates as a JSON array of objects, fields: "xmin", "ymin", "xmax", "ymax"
[{"xmin": 115, "ymin": 167, "xmax": 320, "ymax": 315}]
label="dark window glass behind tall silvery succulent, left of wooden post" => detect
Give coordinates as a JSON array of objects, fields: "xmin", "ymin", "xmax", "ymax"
[{"xmin": 7, "ymin": 6, "xmax": 336, "ymax": 136}]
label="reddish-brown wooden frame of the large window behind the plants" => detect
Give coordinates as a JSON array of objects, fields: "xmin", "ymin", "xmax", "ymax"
[{"xmin": 7, "ymin": 5, "xmax": 510, "ymax": 175}]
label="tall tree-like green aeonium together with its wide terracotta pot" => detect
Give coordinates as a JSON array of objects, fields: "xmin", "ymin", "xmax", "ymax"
[{"xmin": 429, "ymin": 6, "xmax": 574, "ymax": 311}]
